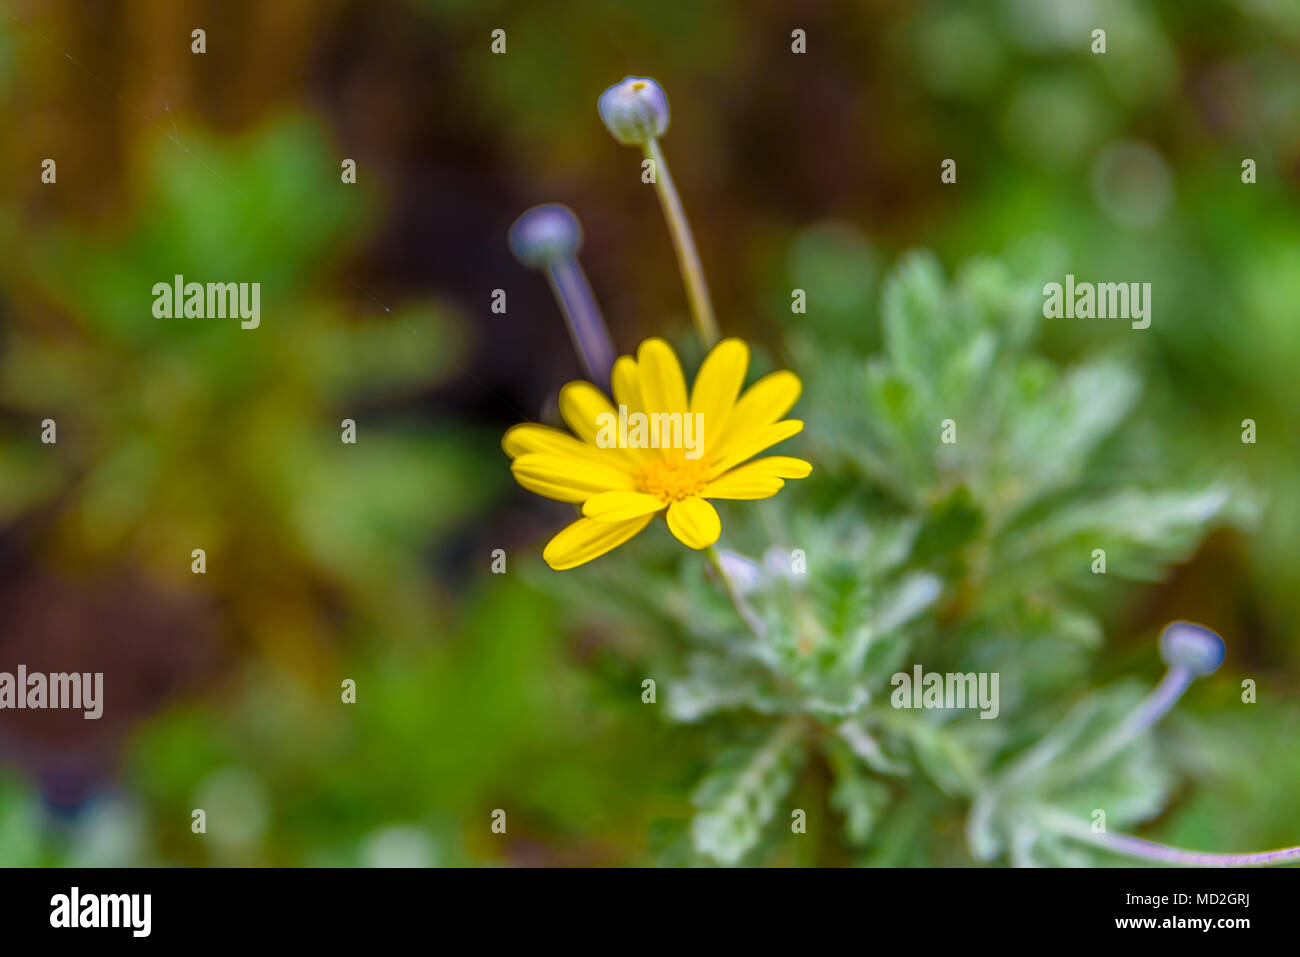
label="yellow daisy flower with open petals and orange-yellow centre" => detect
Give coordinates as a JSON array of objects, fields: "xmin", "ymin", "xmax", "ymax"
[{"xmin": 502, "ymin": 338, "xmax": 813, "ymax": 570}]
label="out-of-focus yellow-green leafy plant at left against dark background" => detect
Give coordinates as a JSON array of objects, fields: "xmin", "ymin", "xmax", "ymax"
[{"xmin": 0, "ymin": 118, "xmax": 491, "ymax": 649}]
